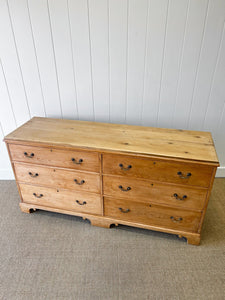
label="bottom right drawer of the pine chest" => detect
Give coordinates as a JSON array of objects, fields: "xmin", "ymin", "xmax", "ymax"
[{"xmin": 104, "ymin": 197, "xmax": 201, "ymax": 232}]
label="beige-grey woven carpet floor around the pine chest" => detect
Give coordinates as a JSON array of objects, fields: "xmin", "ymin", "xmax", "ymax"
[{"xmin": 0, "ymin": 178, "xmax": 225, "ymax": 300}]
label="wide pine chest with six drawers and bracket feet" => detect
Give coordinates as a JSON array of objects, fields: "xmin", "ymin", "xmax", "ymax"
[{"xmin": 5, "ymin": 117, "xmax": 219, "ymax": 245}]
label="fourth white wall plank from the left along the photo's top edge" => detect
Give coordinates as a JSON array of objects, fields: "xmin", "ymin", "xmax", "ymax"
[{"xmin": 48, "ymin": 0, "xmax": 78, "ymax": 119}]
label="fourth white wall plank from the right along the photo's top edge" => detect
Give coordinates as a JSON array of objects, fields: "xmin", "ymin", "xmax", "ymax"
[{"xmin": 142, "ymin": 0, "xmax": 168, "ymax": 126}]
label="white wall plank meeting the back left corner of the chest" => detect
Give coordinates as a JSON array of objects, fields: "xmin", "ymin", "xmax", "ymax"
[{"xmin": 8, "ymin": 0, "xmax": 45, "ymax": 116}]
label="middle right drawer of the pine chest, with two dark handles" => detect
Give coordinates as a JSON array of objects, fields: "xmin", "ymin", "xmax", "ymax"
[{"xmin": 103, "ymin": 175, "xmax": 207, "ymax": 210}]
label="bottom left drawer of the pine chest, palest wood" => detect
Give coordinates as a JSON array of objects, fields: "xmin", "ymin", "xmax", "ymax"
[{"xmin": 19, "ymin": 184, "xmax": 102, "ymax": 214}]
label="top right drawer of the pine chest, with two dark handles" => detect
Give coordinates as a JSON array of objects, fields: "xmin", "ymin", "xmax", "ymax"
[{"xmin": 103, "ymin": 154, "xmax": 213, "ymax": 187}]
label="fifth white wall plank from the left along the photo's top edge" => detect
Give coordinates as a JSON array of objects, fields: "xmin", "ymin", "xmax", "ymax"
[{"xmin": 68, "ymin": 0, "xmax": 94, "ymax": 120}]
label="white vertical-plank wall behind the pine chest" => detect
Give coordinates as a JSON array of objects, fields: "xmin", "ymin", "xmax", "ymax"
[{"xmin": 0, "ymin": 0, "xmax": 225, "ymax": 179}]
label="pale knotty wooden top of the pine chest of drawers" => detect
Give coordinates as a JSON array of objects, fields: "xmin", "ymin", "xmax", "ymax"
[{"xmin": 5, "ymin": 117, "xmax": 219, "ymax": 165}]
